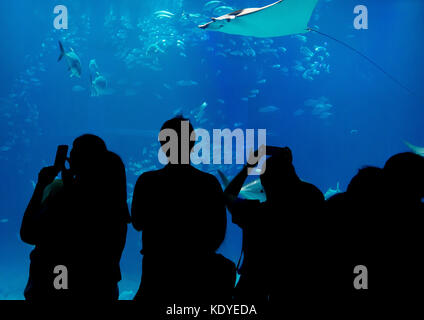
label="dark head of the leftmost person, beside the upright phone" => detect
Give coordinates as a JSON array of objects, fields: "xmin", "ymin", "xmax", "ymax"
[{"xmin": 69, "ymin": 134, "xmax": 107, "ymax": 178}]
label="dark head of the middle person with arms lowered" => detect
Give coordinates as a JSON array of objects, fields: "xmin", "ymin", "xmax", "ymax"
[{"xmin": 159, "ymin": 115, "xmax": 196, "ymax": 164}]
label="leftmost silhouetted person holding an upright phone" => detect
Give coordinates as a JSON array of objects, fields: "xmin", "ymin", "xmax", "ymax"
[{"xmin": 21, "ymin": 135, "xmax": 130, "ymax": 301}]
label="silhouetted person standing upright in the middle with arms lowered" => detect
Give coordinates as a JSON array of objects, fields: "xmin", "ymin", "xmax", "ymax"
[{"xmin": 131, "ymin": 116, "xmax": 235, "ymax": 304}]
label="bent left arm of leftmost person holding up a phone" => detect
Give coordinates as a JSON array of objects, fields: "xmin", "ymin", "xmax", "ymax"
[{"xmin": 20, "ymin": 167, "xmax": 58, "ymax": 245}]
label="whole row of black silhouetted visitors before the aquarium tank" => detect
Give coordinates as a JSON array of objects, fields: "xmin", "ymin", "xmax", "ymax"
[{"xmin": 21, "ymin": 117, "xmax": 424, "ymax": 311}]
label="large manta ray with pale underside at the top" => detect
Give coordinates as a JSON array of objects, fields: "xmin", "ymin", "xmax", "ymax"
[{"xmin": 199, "ymin": 0, "xmax": 318, "ymax": 38}]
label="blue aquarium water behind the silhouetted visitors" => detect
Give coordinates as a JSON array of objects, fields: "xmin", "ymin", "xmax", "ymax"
[{"xmin": 0, "ymin": 0, "xmax": 424, "ymax": 299}]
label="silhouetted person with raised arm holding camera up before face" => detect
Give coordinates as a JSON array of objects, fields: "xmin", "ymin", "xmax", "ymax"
[{"xmin": 225, "ymin": 146, "xmax": 324, "ymax": 314}]
